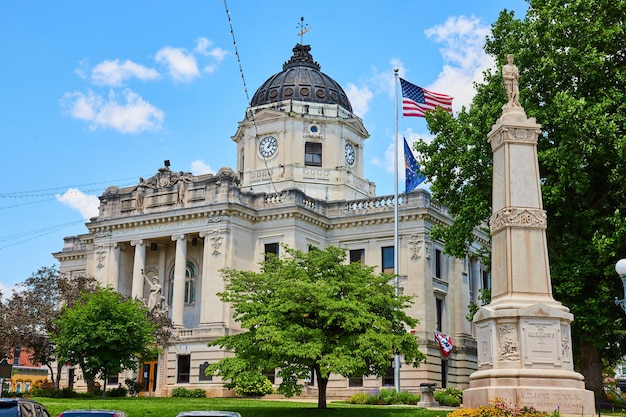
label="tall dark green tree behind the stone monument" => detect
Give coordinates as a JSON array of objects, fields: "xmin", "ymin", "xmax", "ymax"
[{"xmin": 416, "ymin": 0, "xmax": 626, "ymax": 395}]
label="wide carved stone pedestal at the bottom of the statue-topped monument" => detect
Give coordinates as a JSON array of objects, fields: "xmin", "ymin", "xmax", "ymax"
[{"xmin": 463, "ymin": 300, "xmax": 595, "ymax": 416}]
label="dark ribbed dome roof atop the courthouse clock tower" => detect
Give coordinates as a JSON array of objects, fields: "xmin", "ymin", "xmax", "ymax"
[{"xmin": 250, "ymin": 44, "xmax": 352, "ymax": 111}]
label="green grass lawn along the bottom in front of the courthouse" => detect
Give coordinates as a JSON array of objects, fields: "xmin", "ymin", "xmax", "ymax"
[{"xmin": 35, "ymin": 397, "xmax": 448, "ymax": 417}]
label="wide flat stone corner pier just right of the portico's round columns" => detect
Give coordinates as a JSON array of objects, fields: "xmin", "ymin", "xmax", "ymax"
[{"xmin": 200, "ymin": 230, "xmax": 226, "ymax": 327}]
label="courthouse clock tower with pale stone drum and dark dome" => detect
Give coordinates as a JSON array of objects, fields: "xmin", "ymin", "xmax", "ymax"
[{"xmin": 232, "ymin": 44, "xmax": 375, "ymax": 201}]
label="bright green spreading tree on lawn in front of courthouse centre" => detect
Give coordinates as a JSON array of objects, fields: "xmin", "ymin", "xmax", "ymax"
[{"xmin": 207, "ymin": 246, "xmax": 425, "ymax": 408}]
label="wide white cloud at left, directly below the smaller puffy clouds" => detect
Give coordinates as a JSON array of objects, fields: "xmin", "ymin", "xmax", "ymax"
[{"xmin": 61, "ymin": 89, "xmax": 165, "ymax": 133}]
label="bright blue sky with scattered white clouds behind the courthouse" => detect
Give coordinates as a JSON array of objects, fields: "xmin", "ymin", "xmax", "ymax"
[{"xmin": 0, "ymin": 0, "xmax": 528, "ymax": 295}]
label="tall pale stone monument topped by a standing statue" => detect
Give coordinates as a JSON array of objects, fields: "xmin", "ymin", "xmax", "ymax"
[{"xmin": 463, "ymin": 55, "xmax": 595, "ymax": 416}]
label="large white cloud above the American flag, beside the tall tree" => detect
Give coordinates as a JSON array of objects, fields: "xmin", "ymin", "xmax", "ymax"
[{"xmin": 424, "ymin": 16, "xmax": 494, "ymax": 111}]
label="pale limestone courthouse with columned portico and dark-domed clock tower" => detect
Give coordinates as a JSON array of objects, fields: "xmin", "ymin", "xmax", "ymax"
[{"xmin": 54, "ymin": 45, "xmax": 489, "ymax": 397}]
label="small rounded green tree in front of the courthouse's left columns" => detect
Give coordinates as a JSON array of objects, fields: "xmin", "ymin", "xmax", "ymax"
[{"xmin": 53, "ymin": 287, "xmax": 157, "ymax": 396}]
